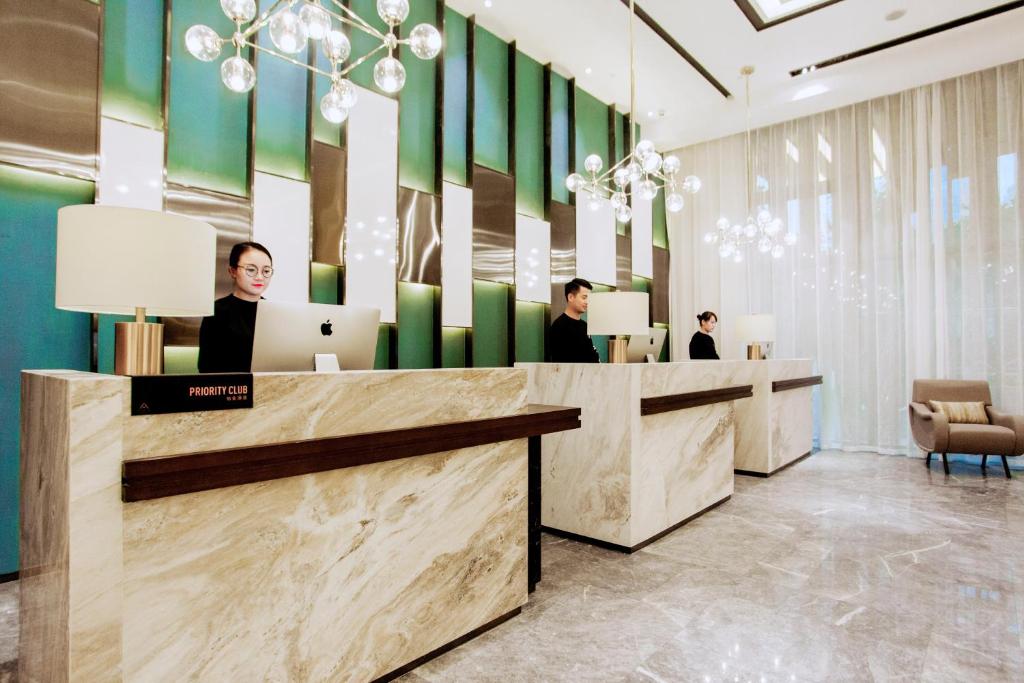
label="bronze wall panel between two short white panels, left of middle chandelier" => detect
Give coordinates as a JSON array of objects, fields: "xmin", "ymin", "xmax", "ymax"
[{"xmin": 473, "ymin": 166, "xmax": 515, "ymax": 285}]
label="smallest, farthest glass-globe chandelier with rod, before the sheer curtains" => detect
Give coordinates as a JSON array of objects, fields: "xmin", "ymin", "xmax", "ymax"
[{"xmin": 705, "ymin": 67, "xmax": 797, "ymax": 263}]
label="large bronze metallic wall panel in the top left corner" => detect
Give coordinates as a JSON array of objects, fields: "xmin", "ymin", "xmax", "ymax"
[{"xmin": 0, "ymin": 0, "xmax": 100, "ymax": 180}]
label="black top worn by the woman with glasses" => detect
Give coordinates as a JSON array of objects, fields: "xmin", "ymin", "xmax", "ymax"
[{"xmin": 199, "ymin": 294, "xmax": 257, "ymax": 373}]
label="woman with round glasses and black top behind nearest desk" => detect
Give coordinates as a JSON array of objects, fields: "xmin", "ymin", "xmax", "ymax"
[{"xmin": 199, "ymin": 242, "xmax": 273, "ymax": 373}]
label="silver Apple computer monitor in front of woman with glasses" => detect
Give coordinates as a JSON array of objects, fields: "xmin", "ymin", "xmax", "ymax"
[{"xmin": 252, "ymin": 299, "xmax": 381, "ymax": 373}]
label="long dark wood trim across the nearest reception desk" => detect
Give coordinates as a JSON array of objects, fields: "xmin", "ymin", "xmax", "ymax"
[{"xmin": 122, "ymin": 405, "xmax": 582, "ymax": 503}]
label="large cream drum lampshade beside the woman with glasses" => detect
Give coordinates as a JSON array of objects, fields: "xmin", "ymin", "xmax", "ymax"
[{"xmin": 56, "ymin": 204, "xmax": 217, "ymax": 315}]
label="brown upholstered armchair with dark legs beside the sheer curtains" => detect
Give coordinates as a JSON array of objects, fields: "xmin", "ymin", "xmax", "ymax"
[{"xmin": 909, "ymin": 380, "xmax": 1024, "ymax": 478}]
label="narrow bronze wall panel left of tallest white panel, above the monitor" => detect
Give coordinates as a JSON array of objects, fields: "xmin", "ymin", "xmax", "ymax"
[{"xmin": 310, "ymin": 142, "xmax": 346, "ymax": 265}]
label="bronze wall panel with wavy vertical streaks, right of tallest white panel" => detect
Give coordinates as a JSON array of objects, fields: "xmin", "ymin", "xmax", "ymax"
[{"xmin": 398, "ymin": 187, "xmax": 441, "ymax": 287}]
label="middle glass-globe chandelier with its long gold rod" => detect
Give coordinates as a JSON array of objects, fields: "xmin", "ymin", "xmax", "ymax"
[{"xmin": 565, "ymin": 0, "xmax": 700, "ymax": 223}]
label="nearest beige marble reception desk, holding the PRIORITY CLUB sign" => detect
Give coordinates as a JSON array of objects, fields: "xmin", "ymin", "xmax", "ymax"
[{"xmin": 19, "ymin": 368, "xmax": 579, "ymax": 683}]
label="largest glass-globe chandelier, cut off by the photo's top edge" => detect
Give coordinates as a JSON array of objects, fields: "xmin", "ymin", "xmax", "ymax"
[{"xmin": 185, "ymin": 0, "xmax": 441, "ymax": 123}]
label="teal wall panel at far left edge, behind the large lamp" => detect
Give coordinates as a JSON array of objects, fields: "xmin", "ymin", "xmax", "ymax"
[{"xmin": 0, "ymin": 166, "xmax": 94, "ymax": 573}]
